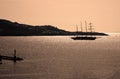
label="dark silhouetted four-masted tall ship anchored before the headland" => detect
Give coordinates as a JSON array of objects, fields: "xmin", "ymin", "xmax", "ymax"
[{"xmin": 71, "ymin": 21, "xmax": 96, "ymax": 40}]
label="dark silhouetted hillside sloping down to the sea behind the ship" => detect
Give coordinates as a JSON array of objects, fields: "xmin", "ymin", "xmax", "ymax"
[{"xmin": 0, "ymin": 19, "xmax": 107, "ymax": 36}]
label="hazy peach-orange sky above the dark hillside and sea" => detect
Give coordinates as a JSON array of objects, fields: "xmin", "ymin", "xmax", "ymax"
[{"xmin": 0, "ymin": 0, "xmax": 120, "ymax": 32}]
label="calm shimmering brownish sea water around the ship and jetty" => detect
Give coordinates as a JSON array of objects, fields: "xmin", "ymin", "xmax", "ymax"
[{"xmin": 0, "ymin": 34, "xmax": 120, "ymax": 79}]
